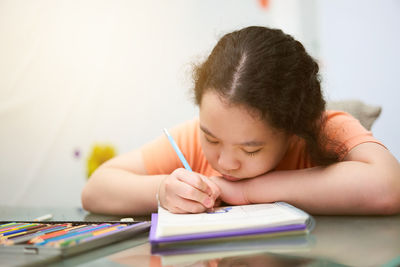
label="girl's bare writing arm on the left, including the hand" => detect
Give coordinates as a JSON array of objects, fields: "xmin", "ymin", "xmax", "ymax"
[{"xmin": 82, "ymin": 150, "xmax": 219, "ymax": 215}]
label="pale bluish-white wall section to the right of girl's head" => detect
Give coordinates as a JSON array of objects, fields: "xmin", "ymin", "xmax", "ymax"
[{"xmin": 317, "ymin": 0, "xmax": 400, "ymax": 160}]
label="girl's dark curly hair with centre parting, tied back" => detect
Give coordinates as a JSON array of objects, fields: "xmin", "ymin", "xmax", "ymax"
[{"xmin": 193, "ymin": 26, "xmax": 340, "ymax": 165}]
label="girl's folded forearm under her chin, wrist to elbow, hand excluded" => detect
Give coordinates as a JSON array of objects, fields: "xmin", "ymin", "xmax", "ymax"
[{"xmin": 245, "ymin": 161, "xmax": 400, "ymax": 214}]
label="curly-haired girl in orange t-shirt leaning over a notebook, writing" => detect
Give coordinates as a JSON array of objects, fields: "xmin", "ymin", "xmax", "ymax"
[{"xmin": 82, "ymin": 27, "xmax": 400, "ymax": 217}]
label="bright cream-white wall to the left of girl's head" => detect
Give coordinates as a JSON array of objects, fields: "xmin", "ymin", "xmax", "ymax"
[{"xmin": 0, "ymin": 0, "xmax": 280, "ymax": 206}]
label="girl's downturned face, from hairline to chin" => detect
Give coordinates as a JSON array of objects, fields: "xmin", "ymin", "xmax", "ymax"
[{"xmin": 200, "ymin": 91, "xmax": 290, "ymax": 181}]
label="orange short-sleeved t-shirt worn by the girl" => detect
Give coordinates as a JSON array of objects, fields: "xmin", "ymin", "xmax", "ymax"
[{"xmin": 141, "ymin": 111, "xmax": 382, "ymax": 176}]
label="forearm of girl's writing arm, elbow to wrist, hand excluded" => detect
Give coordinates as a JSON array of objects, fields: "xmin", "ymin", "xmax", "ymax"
[{"xmin": 82, "ymin": 167, "xmax": 165, "ymax": 215}]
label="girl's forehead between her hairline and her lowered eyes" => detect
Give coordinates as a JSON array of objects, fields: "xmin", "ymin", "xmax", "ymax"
[{"xmin": 200, "ymin": 92, "xmax": 278, "ymax": 142}]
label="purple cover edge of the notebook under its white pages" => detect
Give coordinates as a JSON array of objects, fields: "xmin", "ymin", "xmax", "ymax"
[{"xmin": 149, "ymin": 213, "xmax": 307, "ymax": 245}]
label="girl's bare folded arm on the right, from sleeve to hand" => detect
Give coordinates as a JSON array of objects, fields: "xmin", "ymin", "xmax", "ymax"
[{"xmin": 213, "ymin": 143, "xmax": 400, "ymax": 214}]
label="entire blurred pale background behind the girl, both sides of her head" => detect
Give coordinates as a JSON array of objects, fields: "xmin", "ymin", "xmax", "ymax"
[{"xmin": 0, "ymin": 0, "xmax": 400, "ymax": 206}]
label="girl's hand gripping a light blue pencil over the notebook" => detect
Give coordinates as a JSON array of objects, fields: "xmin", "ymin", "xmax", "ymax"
[{"xmin": 158, "ymin": 129, "xmax": 220, "ymax": 213}]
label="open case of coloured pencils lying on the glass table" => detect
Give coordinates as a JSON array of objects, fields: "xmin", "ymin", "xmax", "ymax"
[{"xmin": 0, "ymin": 221, "xmax": 150, "ymax": 257}]
